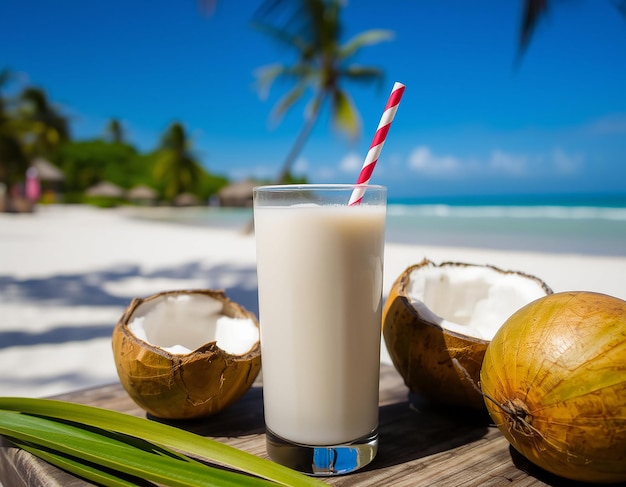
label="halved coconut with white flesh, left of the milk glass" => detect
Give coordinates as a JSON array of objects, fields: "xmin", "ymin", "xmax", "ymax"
[{"xmin": 113, "ymin": 290, "xmax": 261, "ymax": 419}]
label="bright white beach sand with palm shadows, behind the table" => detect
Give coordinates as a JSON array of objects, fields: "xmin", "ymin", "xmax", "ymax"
[{"xmin": 0, "ymin": 206, "xmax": 626, "ymax": 397}]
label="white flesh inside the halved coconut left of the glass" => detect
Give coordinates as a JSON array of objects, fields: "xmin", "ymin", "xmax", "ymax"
[{"xmin": 128, "ymin": 294, "xmax": 259, "ymax": 355}]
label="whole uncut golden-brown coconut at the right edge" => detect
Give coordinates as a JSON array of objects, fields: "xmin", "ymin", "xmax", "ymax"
[{"xmin": 481, "ymin": 291, "xmax": 626, "ymax": 486}]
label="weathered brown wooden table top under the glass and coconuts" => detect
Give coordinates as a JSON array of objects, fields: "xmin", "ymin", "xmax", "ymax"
[{"xmin": 0, "ymin": 365, "xmax": 604, "ymax": 487}]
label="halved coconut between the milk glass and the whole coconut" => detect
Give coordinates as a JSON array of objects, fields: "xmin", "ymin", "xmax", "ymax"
[{"xmin": 383, "ymin": 259, "xmax": 552, "ymax": 409}]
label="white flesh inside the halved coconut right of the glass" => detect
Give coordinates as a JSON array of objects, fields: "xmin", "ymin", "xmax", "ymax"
[{"xmin": 406, "ymin": 265, "xmax": 546, "ymax": 341}]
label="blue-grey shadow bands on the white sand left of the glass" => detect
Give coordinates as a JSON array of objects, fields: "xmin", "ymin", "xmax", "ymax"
[{"xmin": 0, "ymin": 262, "xmax": 258, "ymax": 350}]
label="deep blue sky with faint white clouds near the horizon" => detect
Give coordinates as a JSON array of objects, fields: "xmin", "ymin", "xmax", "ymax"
[{"xmin": 0, "ymin": 0, "xmax": 626, "ymax": 197}]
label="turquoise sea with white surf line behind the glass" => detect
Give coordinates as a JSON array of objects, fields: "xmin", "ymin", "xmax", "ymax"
[{"xmin": 129, "ymin": 193, "xmax": 626, "ymax": 256}]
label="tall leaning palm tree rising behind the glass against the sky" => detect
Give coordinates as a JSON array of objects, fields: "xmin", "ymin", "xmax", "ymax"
[{"xmin": 255, "ymin": 0, "xmax": 393, "ymax": 183}]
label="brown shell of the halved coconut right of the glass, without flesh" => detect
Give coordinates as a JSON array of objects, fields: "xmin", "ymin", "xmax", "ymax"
[{"xmin": 383, "ymin": 259, "xmax": 552, "ymax": 411}]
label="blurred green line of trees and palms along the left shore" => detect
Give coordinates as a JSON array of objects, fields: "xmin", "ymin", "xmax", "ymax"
[{"xmin": 0, "ymin": 69, "xmax": 228, "ymax": 207}]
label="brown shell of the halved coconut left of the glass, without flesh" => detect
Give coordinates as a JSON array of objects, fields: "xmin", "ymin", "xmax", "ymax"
[{"xmin": 112, "ymin": 290, "xmax": 261, "ymax": 419}]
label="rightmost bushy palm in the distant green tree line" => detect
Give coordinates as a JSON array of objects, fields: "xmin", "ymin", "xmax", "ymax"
[{"xmin": 154, "ymin": 122, "xmax": 203, "ymax": 200}]
